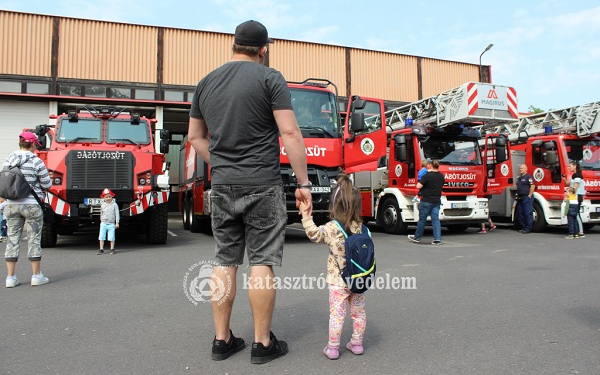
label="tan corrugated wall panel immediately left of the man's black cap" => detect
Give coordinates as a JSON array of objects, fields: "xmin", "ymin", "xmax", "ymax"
[{"xmin": 163, "ymin": 29, "xmax": 233, "ymax": 85}]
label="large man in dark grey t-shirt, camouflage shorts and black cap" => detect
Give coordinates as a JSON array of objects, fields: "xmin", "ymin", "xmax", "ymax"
[{"xmin": 188, "ymin": 21, "xmax": 312, "ymax": 363}]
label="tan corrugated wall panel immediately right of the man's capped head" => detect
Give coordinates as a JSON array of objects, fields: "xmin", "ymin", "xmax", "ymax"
[{"xmin": 269, "ymin": 39, "xmax": 347, "ymax": 96}]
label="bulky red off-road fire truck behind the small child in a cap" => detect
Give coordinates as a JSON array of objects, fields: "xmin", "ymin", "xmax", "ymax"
[{"xmin": 32, "ymin": 106, "xmax": 170, "ymax": 247}]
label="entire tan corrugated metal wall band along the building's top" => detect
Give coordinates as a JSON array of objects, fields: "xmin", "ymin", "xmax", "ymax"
[{"xmin": 0, "ymin": 10, "xmax": 479, "ymax": 102}]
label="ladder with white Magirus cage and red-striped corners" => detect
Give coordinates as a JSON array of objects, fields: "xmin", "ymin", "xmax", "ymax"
[{"xmin": 385, "ymin": 82, "xmax": 518, "ymax": 133}]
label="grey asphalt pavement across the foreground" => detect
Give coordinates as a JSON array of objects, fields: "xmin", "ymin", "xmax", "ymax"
[{"xmin": 0, "ymin": 215, "xmax": 600, "ymax": 375}]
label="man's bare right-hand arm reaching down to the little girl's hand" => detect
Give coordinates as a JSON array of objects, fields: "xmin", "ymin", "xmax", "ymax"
[{"xmin": 273, "ymin": 109, "xmax": 312, "ymax": 215}]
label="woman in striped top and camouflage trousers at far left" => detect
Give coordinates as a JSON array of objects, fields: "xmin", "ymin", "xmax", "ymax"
[{"xmin": 3, "ymin": 132, "xmax": 52, "ymax": 288}]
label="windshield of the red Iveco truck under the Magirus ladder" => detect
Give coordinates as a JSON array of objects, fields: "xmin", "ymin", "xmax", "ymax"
[{"xmin": 421, "ymin": 137, "xmax": 481, "ymax": 165}]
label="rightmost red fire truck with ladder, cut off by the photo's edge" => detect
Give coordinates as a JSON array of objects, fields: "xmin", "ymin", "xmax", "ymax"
[{"xmin": 482, "ymin": 102, "xmax": 600, "ymax": 232}]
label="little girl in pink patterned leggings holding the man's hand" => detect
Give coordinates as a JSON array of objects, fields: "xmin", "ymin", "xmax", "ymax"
[{"xmin": 300, "ymin": 174, "xmax": 367, "ymax": 359}]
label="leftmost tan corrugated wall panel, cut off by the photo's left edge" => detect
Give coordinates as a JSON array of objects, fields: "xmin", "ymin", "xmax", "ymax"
[{"xmin": 0, "ymin": 12, "xmax": 52, "ymax": 77}]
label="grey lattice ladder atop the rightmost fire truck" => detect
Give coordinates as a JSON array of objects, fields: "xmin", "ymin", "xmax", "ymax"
[{"xmin": 480, "ymin": 102, "xmax": 600, "ymax": 142}]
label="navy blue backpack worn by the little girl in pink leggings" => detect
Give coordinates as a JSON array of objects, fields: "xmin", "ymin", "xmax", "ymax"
[{"xmin": 334, "ymin": 220, "xmax": 377, "ymax": 294}]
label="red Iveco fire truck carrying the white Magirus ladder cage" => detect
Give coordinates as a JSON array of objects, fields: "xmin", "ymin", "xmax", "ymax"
[{"xmin": 348, "ymin": 83, "xmax": 518, "ymax": 234}]
